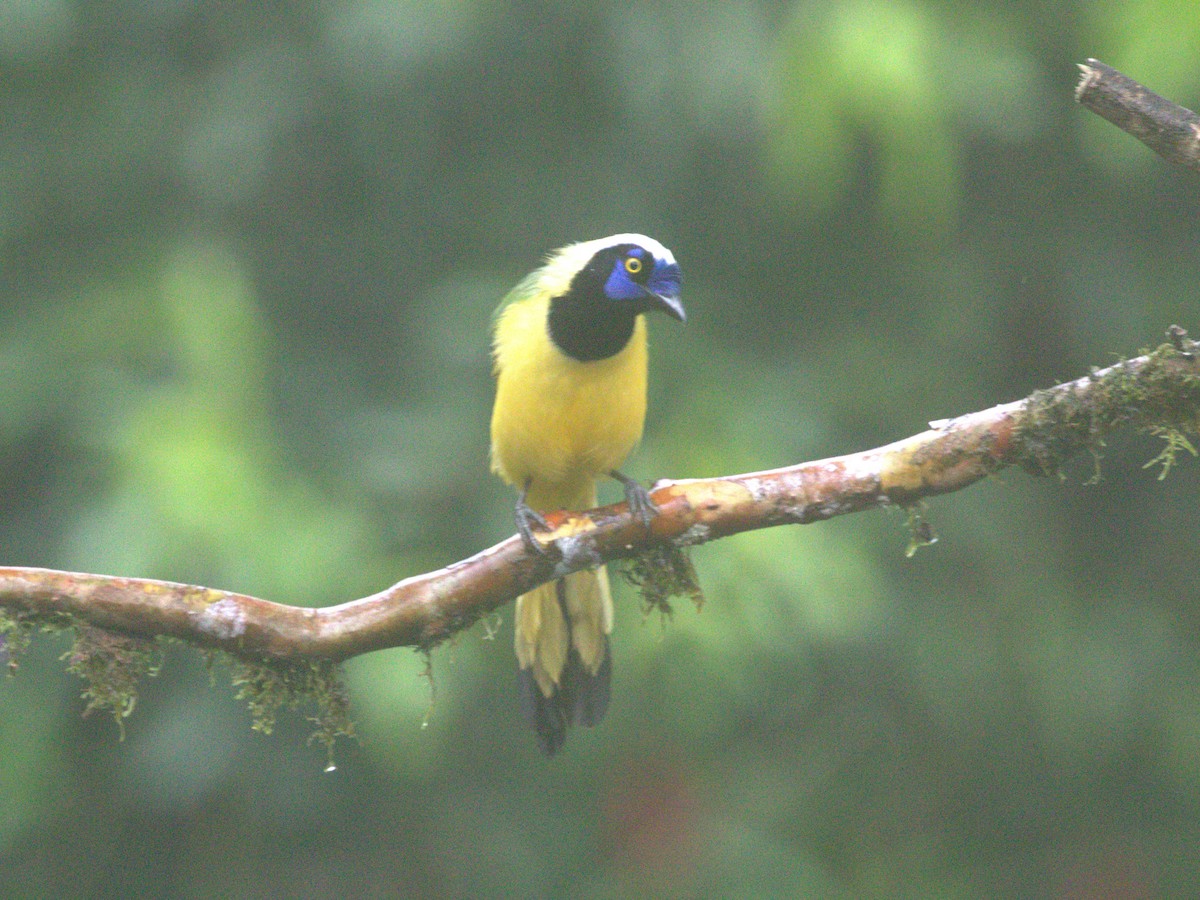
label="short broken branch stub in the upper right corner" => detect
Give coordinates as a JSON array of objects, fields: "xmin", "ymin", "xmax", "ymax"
[{"xmin": 1075, "ymin": 59, "xmax": 1200, "ymax": 169}]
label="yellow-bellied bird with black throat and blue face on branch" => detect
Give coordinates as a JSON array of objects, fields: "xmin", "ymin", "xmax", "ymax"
[{"xmin": 491, "ymin": 234, "xmax": 686, "ymax": 756}]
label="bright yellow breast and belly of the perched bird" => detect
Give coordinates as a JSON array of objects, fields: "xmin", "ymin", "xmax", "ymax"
[{"xmin": 492, "ymin": 298, "xmax": 647, "ymax": 509}]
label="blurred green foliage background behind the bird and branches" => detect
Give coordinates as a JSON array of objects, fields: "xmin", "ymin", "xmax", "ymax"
[{"xmin": 0, "ymin": 0, "xmax": 1200, "ymax": 898}]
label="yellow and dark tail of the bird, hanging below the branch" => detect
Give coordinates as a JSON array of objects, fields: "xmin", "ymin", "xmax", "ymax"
[{"xmin": 515, "ymin": 486, "xmax": 612, "ymax": 755}]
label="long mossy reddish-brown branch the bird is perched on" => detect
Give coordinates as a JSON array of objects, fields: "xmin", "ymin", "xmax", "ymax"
[{"xmin": 0, "ymin": 328, "xmax": 1200, "ymax": 662}]
